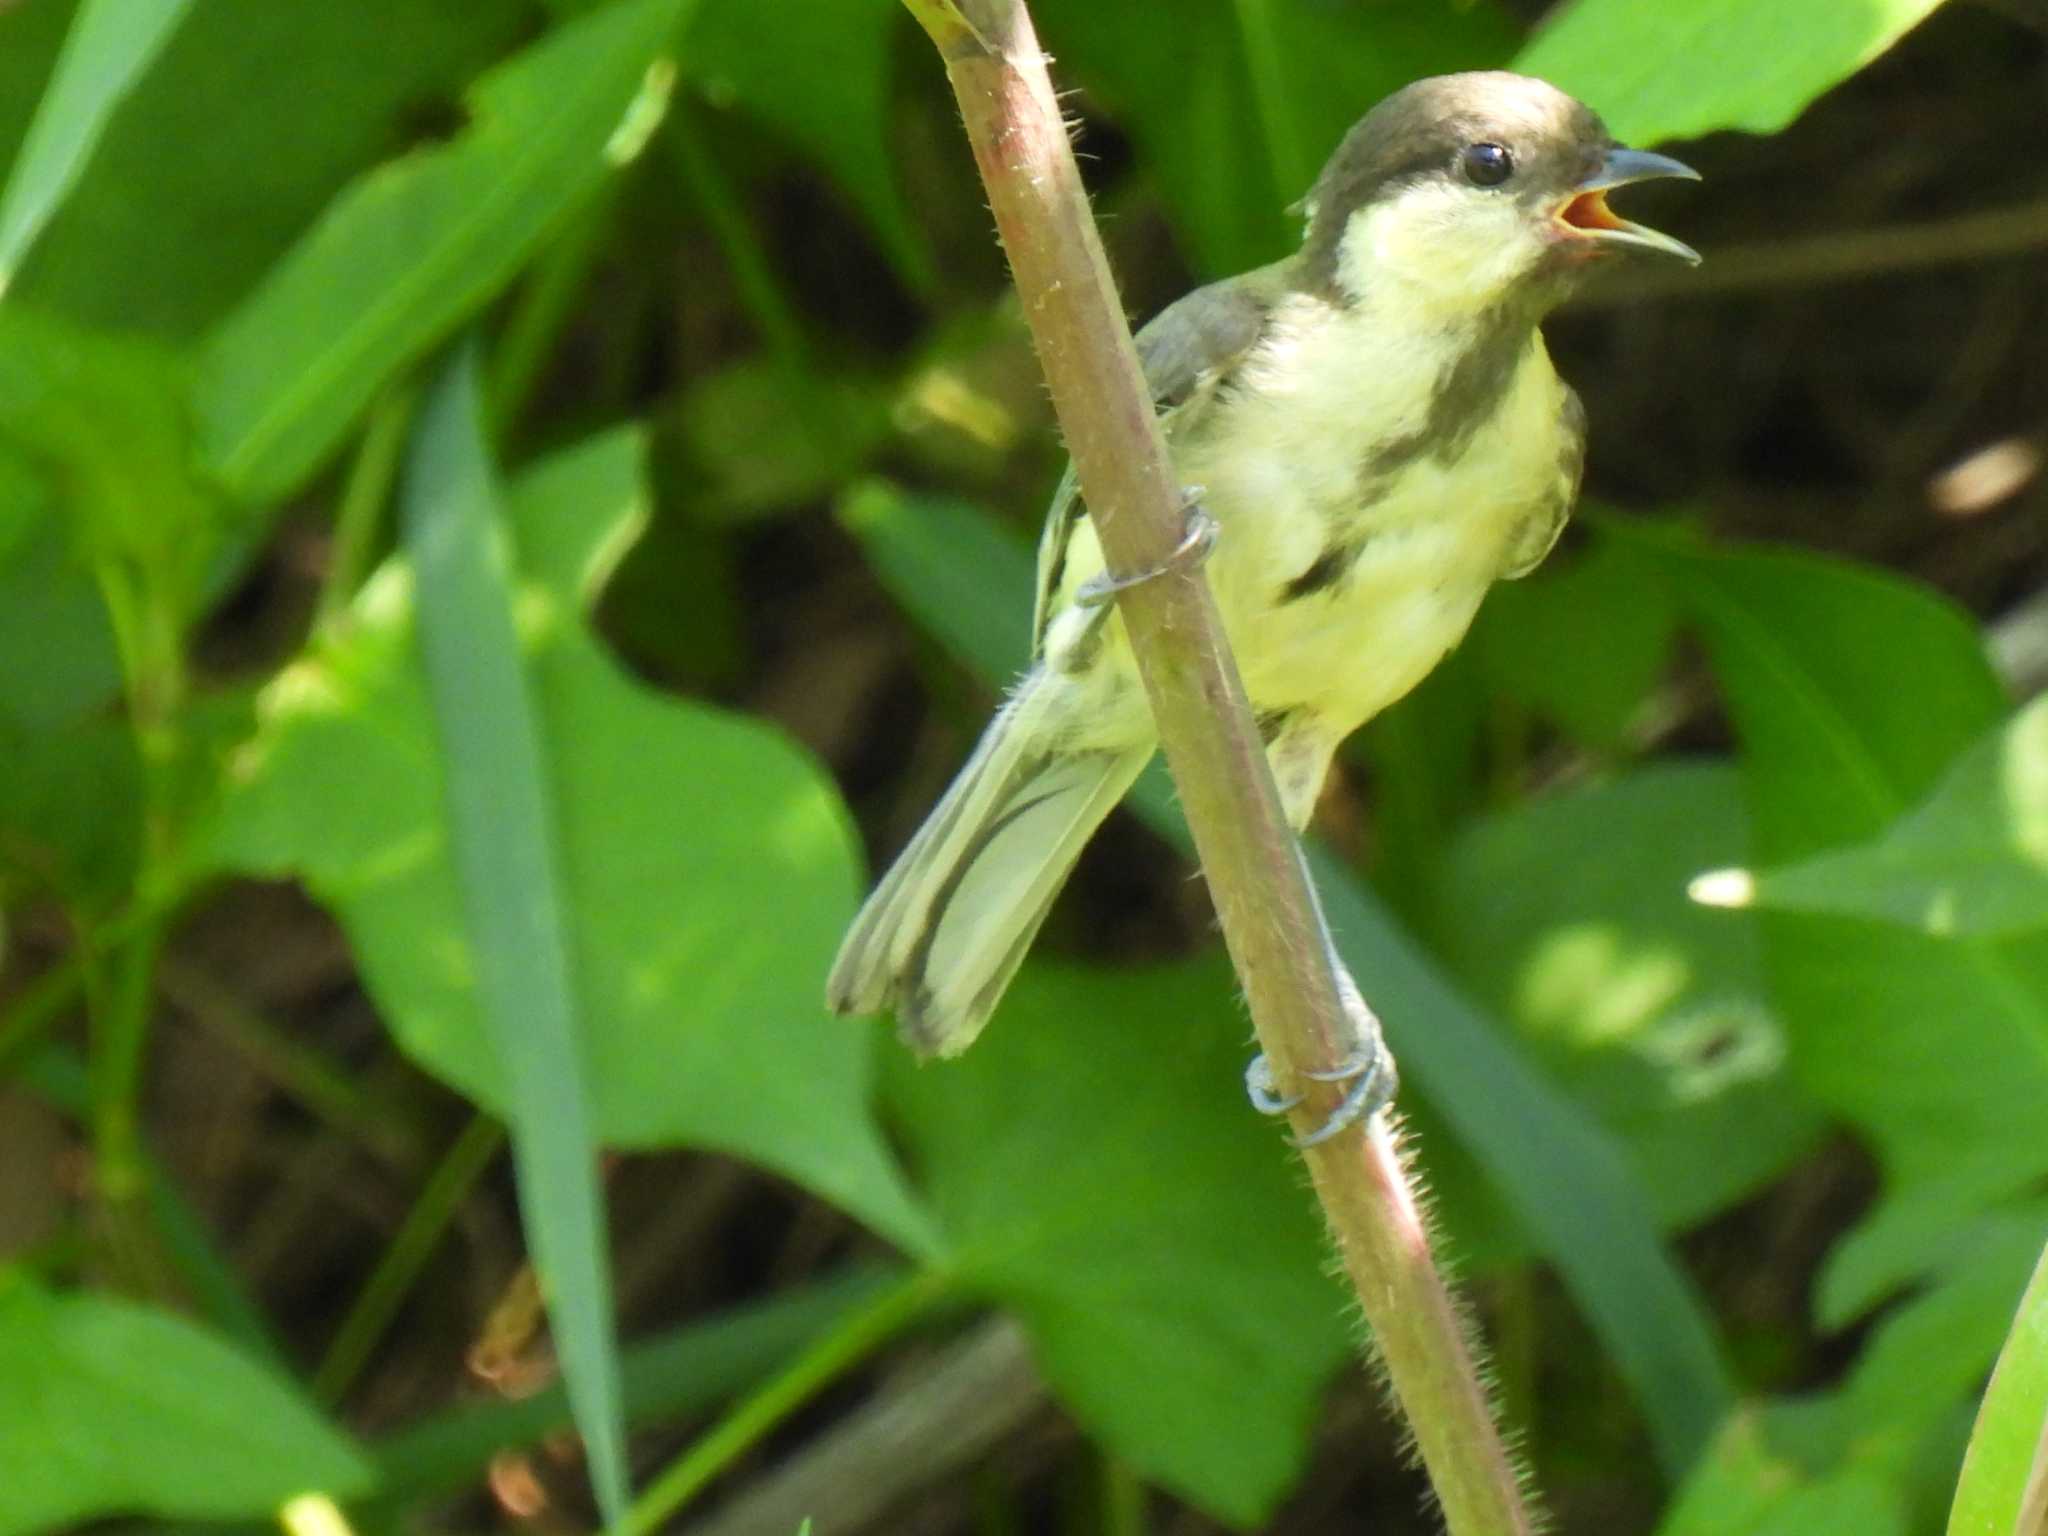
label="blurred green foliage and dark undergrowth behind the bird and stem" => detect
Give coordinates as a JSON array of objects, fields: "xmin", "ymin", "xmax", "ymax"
[{"xmin": 0, "ymin": 0, "xmax": 2048, "ymax": 1536}]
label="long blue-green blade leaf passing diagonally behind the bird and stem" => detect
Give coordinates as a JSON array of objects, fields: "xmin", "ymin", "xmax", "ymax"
[{"xmin": 840, "ymin": 485, "xmax": 1729, "ymax": 1468}]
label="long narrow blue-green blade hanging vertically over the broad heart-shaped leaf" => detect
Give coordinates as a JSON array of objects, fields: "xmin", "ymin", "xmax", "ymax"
[{"xmin": 403, "ymin": 344, "xmax": 627, "ymax": 1522}]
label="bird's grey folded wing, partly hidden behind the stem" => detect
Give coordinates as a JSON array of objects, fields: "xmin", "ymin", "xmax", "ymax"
[{"xmin": 1030, "ymin": 266, "xmax": 1282, "ymax": 659}]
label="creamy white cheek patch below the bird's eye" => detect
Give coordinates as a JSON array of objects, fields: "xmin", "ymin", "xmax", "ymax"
[{"xmin": 1341, "ymin": 178, "xmax": 1542, "ymax": 311}]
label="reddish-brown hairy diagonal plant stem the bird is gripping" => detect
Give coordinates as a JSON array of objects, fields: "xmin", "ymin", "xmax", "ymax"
[{"xmin": 905, "ymin": 0, "xmax": 1530, "ymax": 1536}]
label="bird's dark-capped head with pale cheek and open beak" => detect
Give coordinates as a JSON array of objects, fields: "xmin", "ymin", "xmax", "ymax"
[{"xmin": 1305, "ymin": 72, "xmax": 1700, "ymax": 317}]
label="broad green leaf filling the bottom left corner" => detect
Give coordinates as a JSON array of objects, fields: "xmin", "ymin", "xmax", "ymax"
[{"xmin": 0, "ymin": 1270, "xmax": 371, "ymax": 1536}]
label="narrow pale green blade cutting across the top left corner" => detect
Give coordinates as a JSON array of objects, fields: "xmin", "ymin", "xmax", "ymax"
[{"xmin": 0, "ymin": 0, "xmax": 190, "ymax": 293}]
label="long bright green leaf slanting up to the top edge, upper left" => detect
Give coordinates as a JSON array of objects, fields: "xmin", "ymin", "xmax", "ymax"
[{"xmin": 197, "ymin": 0, "xmax": 686, "ymax": 512}]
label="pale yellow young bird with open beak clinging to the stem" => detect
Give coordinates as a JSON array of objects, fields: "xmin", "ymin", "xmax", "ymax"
[{"xmin": 825, "ymin": 72, "xmax": 1700, "ymax": 1110}]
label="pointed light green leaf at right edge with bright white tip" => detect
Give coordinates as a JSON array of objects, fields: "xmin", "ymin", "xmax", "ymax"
[{"xmin": 1749, "ymin": 700, "xmax": 2048, "ymax": 936}]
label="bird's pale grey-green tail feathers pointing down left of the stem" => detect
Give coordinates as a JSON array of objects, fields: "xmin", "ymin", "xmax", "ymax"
[{"xmin": 825, "ymin": 672, "xmax": 1151, "ymax": 1057}]
